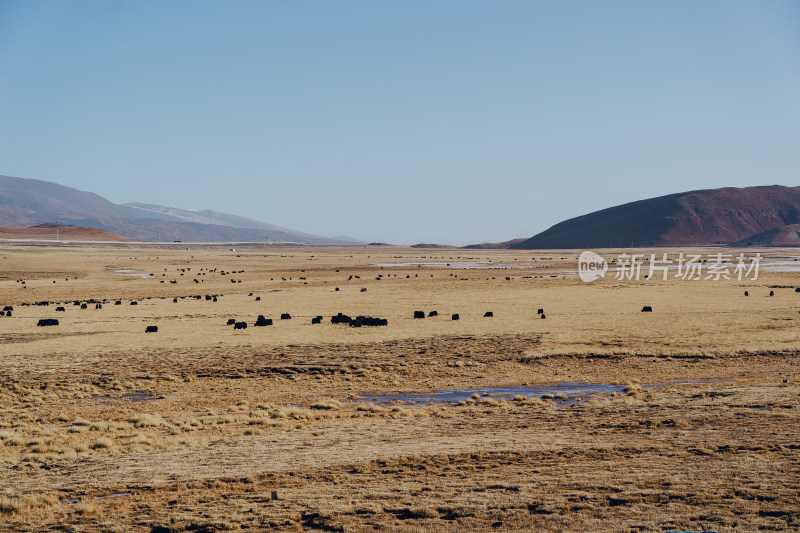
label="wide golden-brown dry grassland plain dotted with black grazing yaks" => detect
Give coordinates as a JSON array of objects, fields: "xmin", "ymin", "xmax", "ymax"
[{"xmin": 0, "ymin": 246, "xmax": 800, "ymax": 532}]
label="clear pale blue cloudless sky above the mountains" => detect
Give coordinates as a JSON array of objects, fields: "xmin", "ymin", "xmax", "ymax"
[{"xmin": 0, "ymin": 0, "xmax": 800, "ymax": 244}]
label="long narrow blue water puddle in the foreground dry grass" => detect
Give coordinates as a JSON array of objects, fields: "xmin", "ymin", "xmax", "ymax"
[{"xmin": 362, "ymin": 383, "xmax": 624, "ymax": 404}]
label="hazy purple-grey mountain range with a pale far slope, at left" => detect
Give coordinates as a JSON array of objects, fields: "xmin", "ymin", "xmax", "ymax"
[{"xmin": 0, "ymin": 176, "xmax": 363, "ymax": 245}]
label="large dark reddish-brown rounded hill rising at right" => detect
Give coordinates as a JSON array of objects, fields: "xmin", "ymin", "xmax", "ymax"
[{"xmin": 512, "ymin": 185, "xmax": 800, "ymax": 249}]
